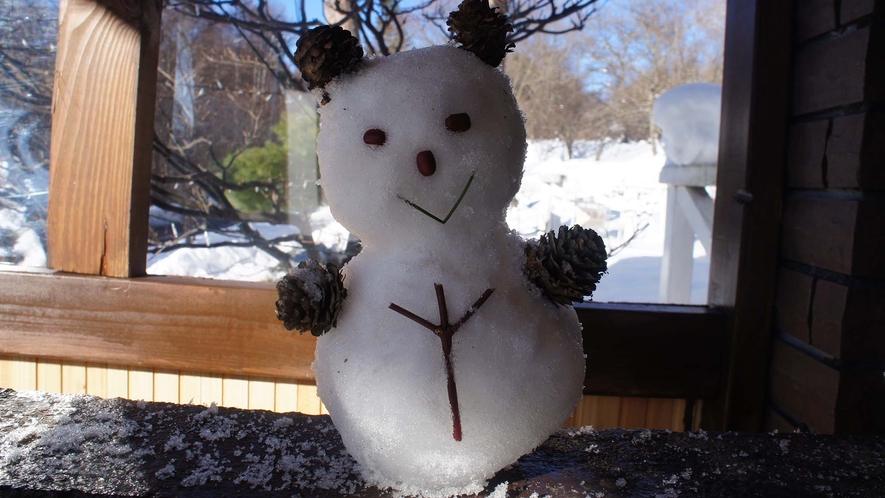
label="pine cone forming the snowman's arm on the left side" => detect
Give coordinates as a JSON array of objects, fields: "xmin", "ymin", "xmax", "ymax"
[{"xmin": 276, "ymin": 259, "xmax": 347, "ymax": 337}]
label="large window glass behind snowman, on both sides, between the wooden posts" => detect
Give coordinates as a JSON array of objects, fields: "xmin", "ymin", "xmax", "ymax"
[{"xmin": 148, "ymin": 0, "xmax": 725, "ymax": 303}]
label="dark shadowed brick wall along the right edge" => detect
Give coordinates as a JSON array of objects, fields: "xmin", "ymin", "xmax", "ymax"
[{"xmin": 763, "ymin": 0, "xmax": 885, "ymax": 433}]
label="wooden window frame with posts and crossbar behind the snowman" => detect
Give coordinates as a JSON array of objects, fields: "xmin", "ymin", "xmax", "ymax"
[{"xmin": 0, "ymin": 0, "xmax": 792, "ymax": 430}]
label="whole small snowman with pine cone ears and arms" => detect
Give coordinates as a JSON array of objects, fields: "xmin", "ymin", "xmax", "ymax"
[{"xmin": 277, "ymin": 0, "xmax": 606, "ymax": 496}]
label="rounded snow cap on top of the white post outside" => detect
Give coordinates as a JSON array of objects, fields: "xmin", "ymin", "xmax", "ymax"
[{"xmin": 653, "ymin": 83, "xmax": 722, "ymax": 166}]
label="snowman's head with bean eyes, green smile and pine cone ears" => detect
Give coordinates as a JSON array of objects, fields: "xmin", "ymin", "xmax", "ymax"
[{"xmin": 296, "ymin": 0, "xmax": 526, "ymax": 249}]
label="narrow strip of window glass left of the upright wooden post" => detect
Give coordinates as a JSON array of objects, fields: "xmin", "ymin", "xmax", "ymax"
[{"xmin": 0, "ymin": 0, "xmax": 58, "ymax": 267}]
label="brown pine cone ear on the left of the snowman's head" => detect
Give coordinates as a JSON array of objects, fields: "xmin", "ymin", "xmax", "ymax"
[{"xmin": 295, "ymin": 26, "xmax": 363, "ymax": 105}]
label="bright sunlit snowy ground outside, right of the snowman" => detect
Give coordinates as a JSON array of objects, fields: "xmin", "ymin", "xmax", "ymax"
[{"xmin": 507, "ymin": 138, "xmax": 710, "ymax": 304}]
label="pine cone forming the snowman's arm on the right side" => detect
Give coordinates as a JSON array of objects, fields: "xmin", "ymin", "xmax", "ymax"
[{"xmin": 523, "ymin": 225, "xmax": 608, "ymax": 306}]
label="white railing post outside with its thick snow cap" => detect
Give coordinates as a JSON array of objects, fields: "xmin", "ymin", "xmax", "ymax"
[{"xmin": 654, "ymin": 83, "xmax": 722, "ymax": 303}]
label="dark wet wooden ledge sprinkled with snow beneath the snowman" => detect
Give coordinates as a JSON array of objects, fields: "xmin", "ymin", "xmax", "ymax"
[{"xmin": 0, "ymin": 389, "xmax": 885, "ymax": 498}]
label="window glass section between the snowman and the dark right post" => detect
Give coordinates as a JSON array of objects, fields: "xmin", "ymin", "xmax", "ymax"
[{"xmin": 506, "ymin": 0, "xmax": 725, "ymax": 304}]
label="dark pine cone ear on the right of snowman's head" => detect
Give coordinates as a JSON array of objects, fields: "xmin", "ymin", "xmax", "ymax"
[{"xmin": 446, "ymin": 0, "xmax": 515, "ymax": 67}]
